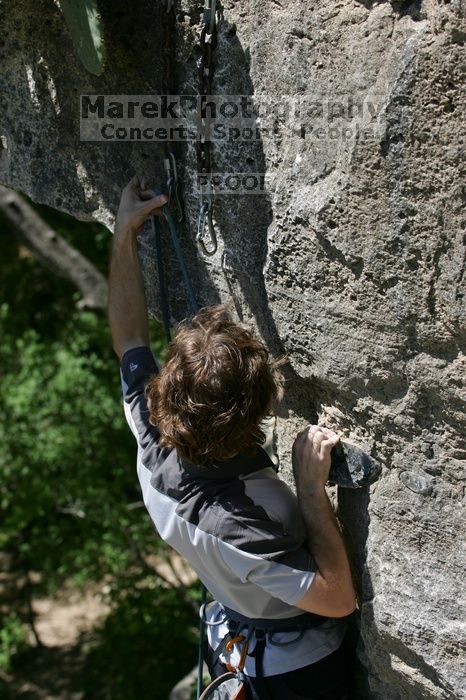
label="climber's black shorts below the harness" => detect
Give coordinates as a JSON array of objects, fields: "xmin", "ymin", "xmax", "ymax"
[{"xmin": 206, "ymin": 638, "xmax": 354, "ymax": 700}]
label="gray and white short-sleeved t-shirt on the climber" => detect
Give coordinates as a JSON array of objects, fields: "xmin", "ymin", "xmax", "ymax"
[{"xmin": 121, "ymin": 347, "xmax": 346, "ymax": 676}]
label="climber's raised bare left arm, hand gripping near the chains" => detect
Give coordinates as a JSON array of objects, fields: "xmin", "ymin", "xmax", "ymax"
[{"xmin": 108, "ymin": 176, "xmax": 167, "ymax": 359}]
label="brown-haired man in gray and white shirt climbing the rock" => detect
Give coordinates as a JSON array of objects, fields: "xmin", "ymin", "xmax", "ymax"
[{"xmin": 109, "ymin": 177, "xmax": 355, "ymax": 700}]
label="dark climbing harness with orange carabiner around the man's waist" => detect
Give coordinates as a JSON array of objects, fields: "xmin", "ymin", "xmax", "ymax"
[{"xmin": 198, "ymin": 601, "xmax": 328, "ymax": 700}]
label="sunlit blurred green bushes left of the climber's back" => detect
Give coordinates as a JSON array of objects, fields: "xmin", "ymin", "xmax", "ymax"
[{"xmin": 0, "ymin": 305, "xmax": 163, "ymax": 587}]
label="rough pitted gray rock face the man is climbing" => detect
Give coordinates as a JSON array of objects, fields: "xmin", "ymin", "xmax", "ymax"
[{"xmin": 0, "ymin": 0, "xmax": 466, "ymax": 700}]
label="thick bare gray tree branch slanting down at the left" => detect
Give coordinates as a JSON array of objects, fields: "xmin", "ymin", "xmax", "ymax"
[{"xmin": 0, "ymin": 185, "xmax": 108, "ymax": 309}]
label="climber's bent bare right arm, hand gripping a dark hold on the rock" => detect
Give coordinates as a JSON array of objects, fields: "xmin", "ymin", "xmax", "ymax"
[{"xmin": 293, "ymin": 426, "xmax": 356, "ymax": 617}]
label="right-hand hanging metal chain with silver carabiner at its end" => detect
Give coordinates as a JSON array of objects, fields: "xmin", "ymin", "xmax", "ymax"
[{"xmin": 196, "ymin": 0, "xmax": 218, "ymax": 255}]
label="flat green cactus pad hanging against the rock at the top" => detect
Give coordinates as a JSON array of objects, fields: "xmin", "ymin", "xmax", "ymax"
[{"xmin": 60, "ymin": 0, "xmax": 105, "ymax": 75}]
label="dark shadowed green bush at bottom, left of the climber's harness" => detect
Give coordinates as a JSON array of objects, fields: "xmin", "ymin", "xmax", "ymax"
[{"xmin": 84, "ymin": 588, "xmax": 197, "ymax": 700}]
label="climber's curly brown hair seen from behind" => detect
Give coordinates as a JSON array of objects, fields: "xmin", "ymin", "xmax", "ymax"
[{"xmin": 146, "ymin": 305, "xmax": 285, "ymax": 466}]
